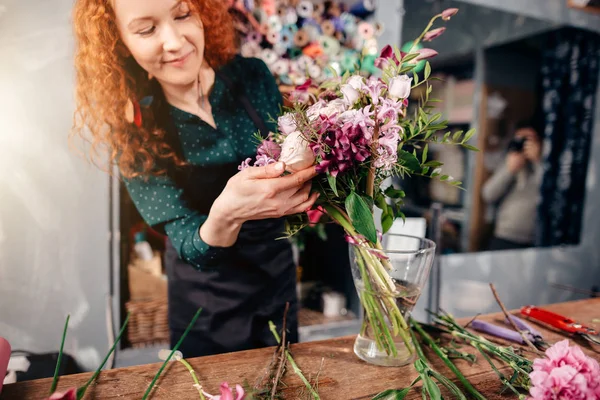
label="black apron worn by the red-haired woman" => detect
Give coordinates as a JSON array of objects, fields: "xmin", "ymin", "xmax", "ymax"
[{"xmin": 165, "ymin": 74, "xmax": 298, "ymax": 357}]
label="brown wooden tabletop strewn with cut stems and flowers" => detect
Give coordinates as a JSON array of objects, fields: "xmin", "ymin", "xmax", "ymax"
[{"xmin": 0, "ymin": 299, "xmax": 600, "ymax": 400}]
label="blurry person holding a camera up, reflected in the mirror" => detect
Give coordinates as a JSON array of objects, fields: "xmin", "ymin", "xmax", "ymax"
[{"xmin": 482, "ymin": 125, "xmax": 542, "ymax": 250}]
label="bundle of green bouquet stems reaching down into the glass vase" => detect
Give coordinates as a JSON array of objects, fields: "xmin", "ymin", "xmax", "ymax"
[{"xmin": 324, "ymin": 204, "xmax": 414, "ymax": 357}]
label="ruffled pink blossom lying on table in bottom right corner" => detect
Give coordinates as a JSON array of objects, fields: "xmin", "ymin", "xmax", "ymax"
[{"xmin": 529, "ymin": 339, "xmax": 600, "ymax": 400}]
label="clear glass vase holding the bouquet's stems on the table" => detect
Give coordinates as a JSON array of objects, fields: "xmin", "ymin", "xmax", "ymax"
[{"xmin": 349, "ymin": 234, "xmax": 435, "ymax": 366}]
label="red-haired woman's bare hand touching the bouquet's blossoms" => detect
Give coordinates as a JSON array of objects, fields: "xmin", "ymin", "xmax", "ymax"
[{"xmin": 200, "ymin": 162, "xmax": 318, "ymax": 247}]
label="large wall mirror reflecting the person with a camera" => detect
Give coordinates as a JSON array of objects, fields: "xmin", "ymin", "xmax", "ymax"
[{"xmin": 395, "ymin": 0, "xmax": 599, "ymax": 254}]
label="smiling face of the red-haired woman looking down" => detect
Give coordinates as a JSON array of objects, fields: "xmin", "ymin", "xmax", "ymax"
[{"xmin": 113, "ymin": 0, "xmax": 204, "ymax": 85}]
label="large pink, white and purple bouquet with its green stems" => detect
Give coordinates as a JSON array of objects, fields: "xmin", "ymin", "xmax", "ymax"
[{"xmin": 240, "ymin": 8, "xmax": 474, "ymax": 365}]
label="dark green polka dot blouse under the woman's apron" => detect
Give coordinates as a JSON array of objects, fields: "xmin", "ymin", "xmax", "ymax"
[{"xmin": 125, "ymin": 56, "xmax": 282, "ymax": 269}]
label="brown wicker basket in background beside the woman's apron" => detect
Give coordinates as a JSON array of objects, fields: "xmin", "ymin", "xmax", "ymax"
[{"xmin": 125, "ymin": 298, "xmax": 169, "ymax": 348}]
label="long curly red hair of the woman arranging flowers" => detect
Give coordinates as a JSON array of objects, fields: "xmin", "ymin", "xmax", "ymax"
[{"xmin": 73, "ymin": 0, "xmax": 237, "ymax": 178}]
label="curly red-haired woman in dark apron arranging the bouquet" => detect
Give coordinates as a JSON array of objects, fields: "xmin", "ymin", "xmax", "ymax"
[{"xmin": 74, "ymin": 0, "xmax": 316, "ymax": 357}]
